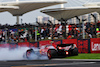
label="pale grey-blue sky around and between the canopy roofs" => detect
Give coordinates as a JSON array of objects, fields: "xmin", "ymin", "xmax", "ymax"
[{"xmin": 0, "ymin": 0, "xmax": 100, "ymax": 25}]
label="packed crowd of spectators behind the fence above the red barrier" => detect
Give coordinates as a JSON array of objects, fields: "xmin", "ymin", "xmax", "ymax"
[{"xmin": 0, "ymin": 22, "xmax": 100, "ymax": 43}]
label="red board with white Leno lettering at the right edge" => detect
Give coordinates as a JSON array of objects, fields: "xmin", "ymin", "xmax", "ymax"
[{"xmin": 91, "ymin": 38, "xmax": 100, "ymax": 53}]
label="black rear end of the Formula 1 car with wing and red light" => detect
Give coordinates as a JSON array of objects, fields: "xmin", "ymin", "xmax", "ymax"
[{"xmin": 47, "ymin": 44, "xmax": 78, "ymax": 59}]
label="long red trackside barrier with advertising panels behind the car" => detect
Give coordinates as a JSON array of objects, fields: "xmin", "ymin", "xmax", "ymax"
[{"xmin": 0, "ymin": 38, "xmax": 100, "ymax": 53}]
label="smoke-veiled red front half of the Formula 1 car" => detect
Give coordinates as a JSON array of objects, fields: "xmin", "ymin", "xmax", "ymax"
[{"xmin": 23, "ymin": 45, "xmax": 55, "ymax": 60}]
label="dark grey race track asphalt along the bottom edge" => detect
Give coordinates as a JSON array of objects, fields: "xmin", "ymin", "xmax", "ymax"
[{"xmin": 0, "ymin": 59, "xmax": 100, "ymax": 67}]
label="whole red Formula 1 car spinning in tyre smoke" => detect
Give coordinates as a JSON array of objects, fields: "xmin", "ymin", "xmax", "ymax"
[{"xmin": 24, "ymin": 44, "xmax": 78, "ymax": 59}]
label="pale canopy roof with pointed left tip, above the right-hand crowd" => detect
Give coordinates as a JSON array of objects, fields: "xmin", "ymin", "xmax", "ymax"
[{"xmin": 41, "ymin": 6, "xmax": 100, "ymax": 21}]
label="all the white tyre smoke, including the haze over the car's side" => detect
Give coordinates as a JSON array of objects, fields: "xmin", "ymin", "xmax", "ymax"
[{"xmin": 0, "ymin": 47, "xmax": 48, "ymax": 61}]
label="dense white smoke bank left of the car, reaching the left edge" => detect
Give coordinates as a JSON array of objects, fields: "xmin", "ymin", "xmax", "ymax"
[{"xmin": 0, "ymin": 47, "xmax": 29, "ymax": 61}]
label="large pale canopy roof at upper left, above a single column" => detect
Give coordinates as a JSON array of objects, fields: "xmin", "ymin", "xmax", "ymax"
[{"xmin": 0, "ymin": 1, "xmax": 66, "ymax": 16}]
